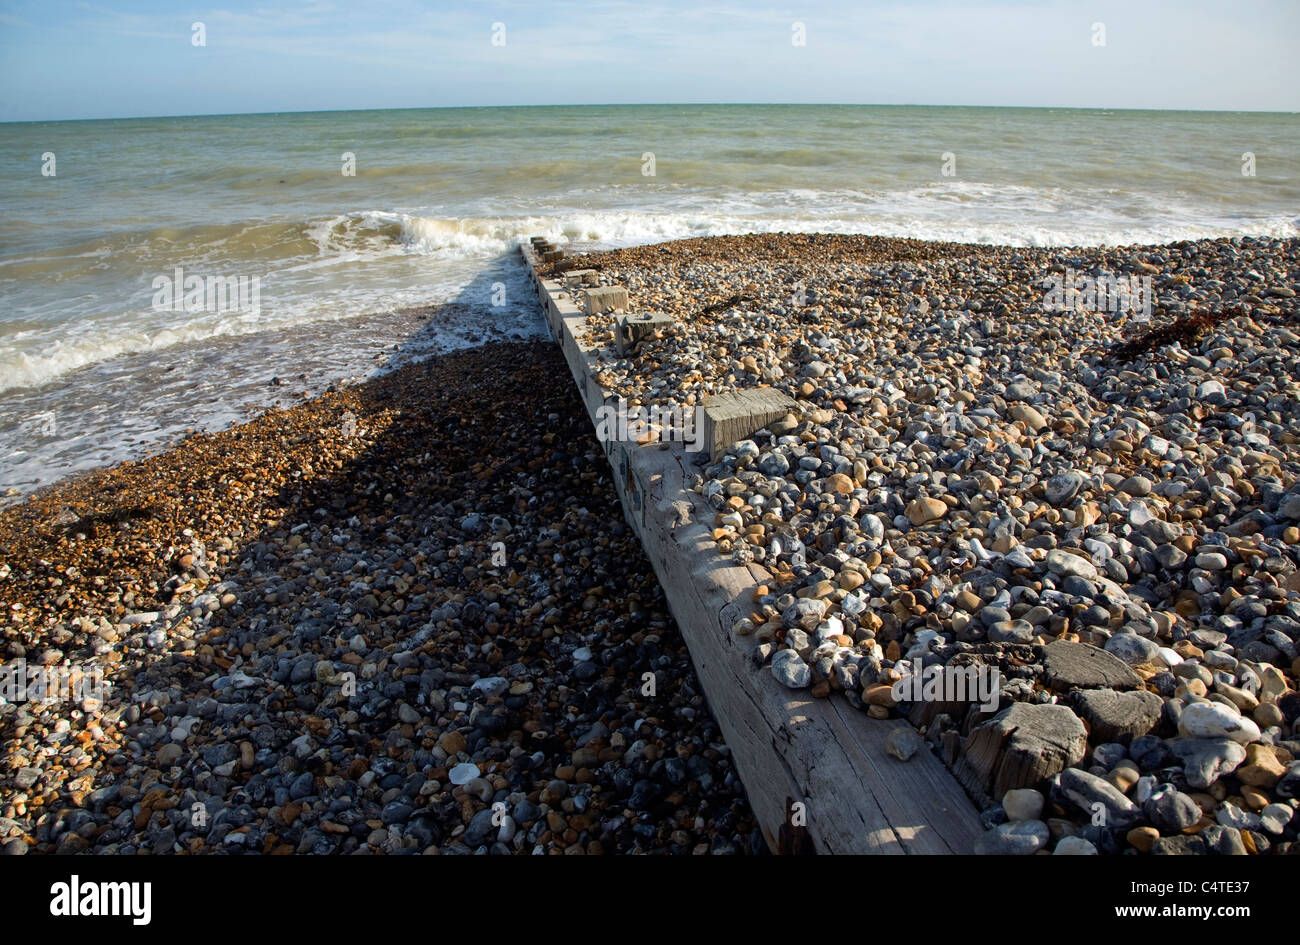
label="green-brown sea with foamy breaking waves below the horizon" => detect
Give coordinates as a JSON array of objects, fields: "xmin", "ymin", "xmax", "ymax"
[{"xmin": 0, "ymin": 105, "xmax": 1300, "ymax": 500}]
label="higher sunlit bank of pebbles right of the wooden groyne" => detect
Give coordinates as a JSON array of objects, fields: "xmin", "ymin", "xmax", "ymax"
[{"xmin": 571, "ymin": 234, "xmax": 1300, "ymax": 854}]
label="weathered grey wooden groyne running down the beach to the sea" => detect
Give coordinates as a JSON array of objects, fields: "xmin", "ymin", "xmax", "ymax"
[{"xmin": 520, "ymin": 242, "xmax": 983, "ymax": 854}]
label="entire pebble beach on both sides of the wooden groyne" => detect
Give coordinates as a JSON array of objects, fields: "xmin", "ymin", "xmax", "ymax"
[{"xmin": 0, "ymin": 234, "xmax": 1300, "ymax": 855}]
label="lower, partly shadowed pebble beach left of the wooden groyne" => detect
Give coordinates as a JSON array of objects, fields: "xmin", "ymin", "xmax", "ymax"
[{"xmin": 0, "ymin": 343, "xmax": 767, "ymax": 854}]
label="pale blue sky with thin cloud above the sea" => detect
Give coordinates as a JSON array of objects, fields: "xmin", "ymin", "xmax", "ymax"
[{"xmin": 0, "ymin": 0, "xmax": 1300, "ymax": 121}]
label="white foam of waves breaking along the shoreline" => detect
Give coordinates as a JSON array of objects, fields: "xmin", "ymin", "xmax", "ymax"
[{"xmin": 0, "ymin": 189, "xmax": 1300, "ymax": 391}]
